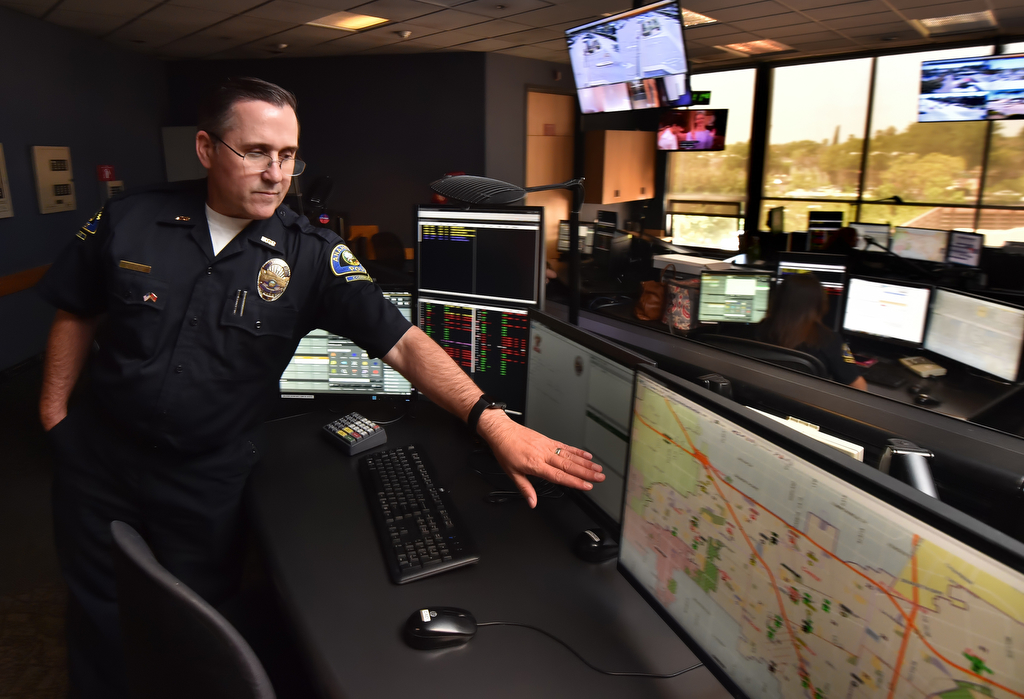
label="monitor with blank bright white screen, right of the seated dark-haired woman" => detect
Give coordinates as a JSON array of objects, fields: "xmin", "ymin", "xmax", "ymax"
[{"xmin": 843, "ymin": 276, "xmax": 932, "ymax": 347}]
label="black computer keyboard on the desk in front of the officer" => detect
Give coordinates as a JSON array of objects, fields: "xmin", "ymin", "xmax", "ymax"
[{"xmin": 359, "ymin": 446, "xmax": 480, "ymax": 584}]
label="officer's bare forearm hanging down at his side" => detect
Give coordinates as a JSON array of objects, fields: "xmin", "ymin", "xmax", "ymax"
[{"xmin": 39, "ymin": 310, "xmax": 98, "ymax": 432}]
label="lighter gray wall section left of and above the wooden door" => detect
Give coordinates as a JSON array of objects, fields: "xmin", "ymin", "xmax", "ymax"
[{"xmin": 481, "ymin": 53, "xmax": 582, "ymax": 186}]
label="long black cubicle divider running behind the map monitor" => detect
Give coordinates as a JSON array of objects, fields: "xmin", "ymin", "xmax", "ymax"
[{"xmin": 548, "ymin": 303, "xmax": 1024, "ymax": 540}]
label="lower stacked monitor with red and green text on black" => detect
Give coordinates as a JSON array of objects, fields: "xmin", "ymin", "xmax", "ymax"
[{"xmin": 417, "ymin": 296, "xmax": 529, "ymax": 422}]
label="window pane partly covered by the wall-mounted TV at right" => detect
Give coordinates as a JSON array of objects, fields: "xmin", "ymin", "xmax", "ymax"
[{"xmin": 862, "ymin": 46, "xmax": 992, "ymax": 204}]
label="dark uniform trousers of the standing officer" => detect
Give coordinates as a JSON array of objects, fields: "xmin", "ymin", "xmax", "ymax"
[{"xmin": 49, "ymin": 405, "xmax": 259, "ymax": 699}]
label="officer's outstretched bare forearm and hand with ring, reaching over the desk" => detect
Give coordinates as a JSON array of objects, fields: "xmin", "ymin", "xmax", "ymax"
[{"xmin": 383, "ymin": 327, "xmax": 604, "ymax": 508}]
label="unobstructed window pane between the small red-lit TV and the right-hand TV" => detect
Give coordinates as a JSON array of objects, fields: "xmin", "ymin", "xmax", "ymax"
[{"xmin": 765, "ymin": 58, "xmax": 871, "ymax": 200}]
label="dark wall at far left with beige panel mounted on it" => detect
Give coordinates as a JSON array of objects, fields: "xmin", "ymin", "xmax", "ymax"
[{"xmin": 0, "ymin": 7, "xmax": 167, "ymax": 369}]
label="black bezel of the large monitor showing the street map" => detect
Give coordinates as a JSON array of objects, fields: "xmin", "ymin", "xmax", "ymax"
[{"xmin": 615, "ymin": 366, "xmax": 1024, "ymax": 697}]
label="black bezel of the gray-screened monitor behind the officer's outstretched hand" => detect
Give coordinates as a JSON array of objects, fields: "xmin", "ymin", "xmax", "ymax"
[{"xmin": 523, "ymin": 309, "xmax": 656, "ymax": 540}]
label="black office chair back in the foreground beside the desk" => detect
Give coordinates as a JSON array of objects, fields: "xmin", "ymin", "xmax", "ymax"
[{"xmin": 111, "ymin": 522, "xmax": 274, "ymax": 699}]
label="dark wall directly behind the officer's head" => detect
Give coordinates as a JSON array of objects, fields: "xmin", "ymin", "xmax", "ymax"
[{"xmin": 168, "ymin": 52, "xmax": 487, "ymax": 246}]
